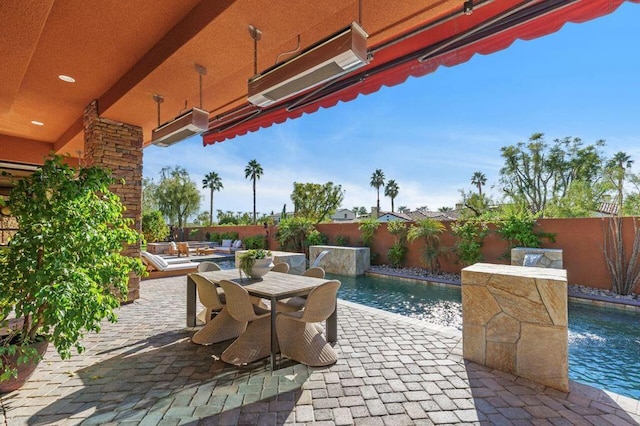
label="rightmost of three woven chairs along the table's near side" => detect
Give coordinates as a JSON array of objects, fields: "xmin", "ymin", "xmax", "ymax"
[{"xmin": 276, "ymin": 280, "xmax": 340, "ymax": 367}]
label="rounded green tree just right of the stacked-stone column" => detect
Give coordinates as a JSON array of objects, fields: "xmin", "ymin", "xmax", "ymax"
[{"xmin": 155, "ymin": 166, "xmax": 201, "ymax": 228}]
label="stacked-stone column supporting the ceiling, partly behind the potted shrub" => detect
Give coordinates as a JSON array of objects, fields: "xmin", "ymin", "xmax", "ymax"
[{"xmin": 84, "ymin": 100, "xmax": 143, "ymax": 302}]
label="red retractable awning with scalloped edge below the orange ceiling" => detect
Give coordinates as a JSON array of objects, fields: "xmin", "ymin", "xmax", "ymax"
[{"xmin": 202, "ymin": 0, "xmax": 640, "ymax": 145}]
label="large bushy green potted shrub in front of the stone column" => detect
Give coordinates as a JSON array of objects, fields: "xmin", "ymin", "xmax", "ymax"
[{"xmin": 0, "ymin": 156, "xmax": 144, "ymax": 392}]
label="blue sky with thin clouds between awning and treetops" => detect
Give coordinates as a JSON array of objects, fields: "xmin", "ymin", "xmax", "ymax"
[{"xmin": 143, "ymin": 3, "xmax": 640, "ymax": 221}]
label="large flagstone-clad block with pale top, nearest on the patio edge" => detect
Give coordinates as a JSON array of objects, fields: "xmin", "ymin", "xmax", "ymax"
[{"xmin": 462, "ymin": 263, "xmax": 569, "ymax": 392}]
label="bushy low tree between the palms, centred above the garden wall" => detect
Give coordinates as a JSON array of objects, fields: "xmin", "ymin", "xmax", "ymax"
[{"xmin": 291, "ymin": 182, "xmax": 344, "ymax": 224}]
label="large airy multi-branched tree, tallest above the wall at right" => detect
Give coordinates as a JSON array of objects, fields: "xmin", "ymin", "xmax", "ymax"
[{"xmin": 500, "ymin": 133, "xmax": 604, "ymax": 214}]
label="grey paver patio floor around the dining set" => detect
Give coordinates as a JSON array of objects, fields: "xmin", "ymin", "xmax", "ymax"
[{"xmin": 0, "ymin": 277, "xmax": 640, "ymax": 426}]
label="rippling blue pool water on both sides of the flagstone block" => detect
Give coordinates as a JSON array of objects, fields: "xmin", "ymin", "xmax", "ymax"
[{"xmin": 331, "ymin": 275, "xmax": 640, "ymax": 399}]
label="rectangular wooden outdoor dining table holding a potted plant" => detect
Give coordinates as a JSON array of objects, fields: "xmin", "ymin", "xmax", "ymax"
[{"xmin": 187, "ymin": 269, "xmax": 338, "ymax": 369}]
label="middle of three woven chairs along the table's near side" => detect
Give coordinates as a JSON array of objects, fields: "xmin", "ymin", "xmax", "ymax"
[{"xmin": 220, "ymin": 280, "xmax": 271, "ymax": 365}]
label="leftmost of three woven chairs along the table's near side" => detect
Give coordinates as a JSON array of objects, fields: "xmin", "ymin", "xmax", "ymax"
[{"xmin": 189, "ymin": 274, "xmax": 247, "ymax": 345}]
